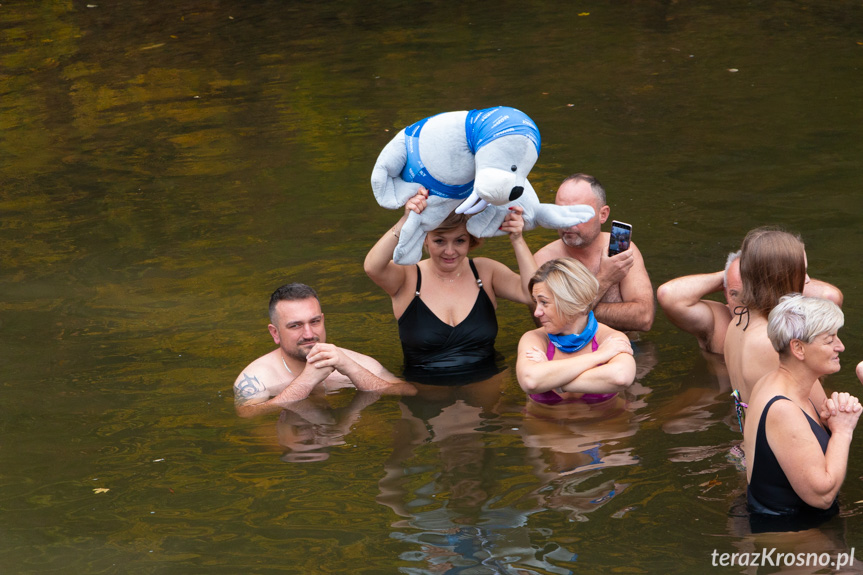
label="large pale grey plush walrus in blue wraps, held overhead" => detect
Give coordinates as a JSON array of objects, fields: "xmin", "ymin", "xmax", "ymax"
[{"xmin": 372, "ymin": 107, "xmax": 594, "ymax": 265}]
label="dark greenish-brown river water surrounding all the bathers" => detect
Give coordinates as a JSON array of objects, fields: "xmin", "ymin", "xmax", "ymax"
[{"xmin": 0, "ymin": 0, "xmax": 863, "ymax": 574}]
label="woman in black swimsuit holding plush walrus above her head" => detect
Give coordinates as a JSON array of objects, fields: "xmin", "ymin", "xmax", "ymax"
[{"xmin": 365, "ymin": 189, "xmax": 536, "ymax": 383}]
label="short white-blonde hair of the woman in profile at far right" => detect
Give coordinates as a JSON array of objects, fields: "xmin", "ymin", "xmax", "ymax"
[{"xmin": 767, "ymin": 294, "xmax": 845, "ymax": 354}]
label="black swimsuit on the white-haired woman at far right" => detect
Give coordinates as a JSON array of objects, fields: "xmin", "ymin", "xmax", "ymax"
[{"xmin": 746, "ymin": 395, "xmax": 839, "ymax": 516}]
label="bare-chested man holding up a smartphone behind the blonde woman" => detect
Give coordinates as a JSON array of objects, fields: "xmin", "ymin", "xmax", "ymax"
[{"xmin": 533, "ymin": 174, "xmax": 655, "ymax": 331}]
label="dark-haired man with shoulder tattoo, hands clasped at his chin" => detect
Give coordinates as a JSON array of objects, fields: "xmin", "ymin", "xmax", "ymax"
[{"xmin": 234, "ymin": 283, "xmax": 415, "ymax": 417}]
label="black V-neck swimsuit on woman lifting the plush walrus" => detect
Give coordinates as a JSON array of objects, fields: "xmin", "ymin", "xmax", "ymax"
[{"xmin": 398, "ymin": 260, "xmax": 497, "ymax": 381}]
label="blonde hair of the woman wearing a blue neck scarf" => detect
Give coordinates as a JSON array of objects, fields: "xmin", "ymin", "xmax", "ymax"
[{"xmin": 528, "ymin": 258, "xmax": 599, "ymax": 322}]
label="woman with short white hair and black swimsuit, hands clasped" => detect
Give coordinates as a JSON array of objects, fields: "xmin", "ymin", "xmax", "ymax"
[{"xmin": 743, "ymin": 294, "xmax": 861, "ymax": 519}]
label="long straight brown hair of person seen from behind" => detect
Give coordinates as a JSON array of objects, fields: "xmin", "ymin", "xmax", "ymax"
[{"xmin": 740, "ymin": 227, "xmax": 806, "ymax": 315}]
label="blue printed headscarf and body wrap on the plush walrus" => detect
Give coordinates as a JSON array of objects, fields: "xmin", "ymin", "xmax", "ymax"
[{"xmin": 401, "ymin": 106, "xmax": 540, "ymax": 200}]
